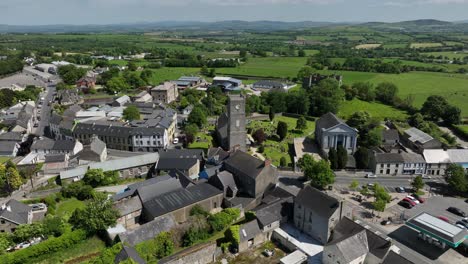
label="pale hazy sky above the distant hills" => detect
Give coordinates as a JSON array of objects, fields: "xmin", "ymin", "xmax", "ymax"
[{"xmin": 0, "ymin": 0, "xmax": 468, "ymax": 25}]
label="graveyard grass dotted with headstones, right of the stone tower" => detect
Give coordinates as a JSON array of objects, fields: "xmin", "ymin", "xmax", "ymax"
[{"xmin": 248, "ymin": 116, "xmax": 315, "ymax": 166}]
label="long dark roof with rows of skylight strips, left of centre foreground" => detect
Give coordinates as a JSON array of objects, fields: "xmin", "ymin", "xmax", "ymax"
[{"xmin": 143, "ymin": 183, "xmax": 222, "ymax": 218}]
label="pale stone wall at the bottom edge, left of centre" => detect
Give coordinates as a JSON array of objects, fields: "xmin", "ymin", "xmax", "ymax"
[{"xmin": 158, "ymin": 242, "xmax": 221, "ymax": 264}]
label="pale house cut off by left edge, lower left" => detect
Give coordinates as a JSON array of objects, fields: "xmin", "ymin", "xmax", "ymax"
[{"xmin": 0, "ymin": 199, "xmax": 32, "ymax": 233}]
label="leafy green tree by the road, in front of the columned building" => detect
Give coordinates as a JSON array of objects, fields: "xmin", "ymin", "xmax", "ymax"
[{"xmin": 299, "ymin": 154, "xmax": 335, "ymax": 189}]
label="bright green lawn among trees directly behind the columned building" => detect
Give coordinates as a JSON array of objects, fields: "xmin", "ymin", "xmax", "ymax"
[{"xmin": 338, "ymin": 99, "xmax": 408, "ymax": 120}]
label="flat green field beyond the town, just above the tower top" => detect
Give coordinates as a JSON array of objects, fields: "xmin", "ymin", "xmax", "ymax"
[{"xmin": 216, "ymin": 57, "xmax": 307, "ymax": 78}]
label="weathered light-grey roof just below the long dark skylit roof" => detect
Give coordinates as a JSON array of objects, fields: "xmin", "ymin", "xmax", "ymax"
[{"xmin": 118, "ymin": 215, "xmax": 176, "ymax": 246}]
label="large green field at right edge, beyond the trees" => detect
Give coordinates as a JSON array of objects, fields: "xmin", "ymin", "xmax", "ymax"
[{"xmin": 322, "ymin": 71, "xmax": 468, "ymax": 117}]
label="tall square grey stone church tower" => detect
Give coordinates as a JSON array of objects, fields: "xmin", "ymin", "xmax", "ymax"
[{"xmin": 216, "ymin": 95, "xmax": 247, "ymax": 151}]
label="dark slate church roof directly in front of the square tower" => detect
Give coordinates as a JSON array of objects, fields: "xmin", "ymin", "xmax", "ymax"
[{"xmin": 224, "ymin": 150, "xmax": 265, "ymax": 179}]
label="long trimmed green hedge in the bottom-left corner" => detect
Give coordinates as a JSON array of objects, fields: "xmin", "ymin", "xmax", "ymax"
[{"xmin": 0, "ymin": 230, "xmax": 86, "ymax": 264}]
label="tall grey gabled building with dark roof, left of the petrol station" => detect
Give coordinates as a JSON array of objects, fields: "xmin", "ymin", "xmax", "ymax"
[{"xmin": 294, "ymin": 185, "xmax": 352, "ymax": 244}]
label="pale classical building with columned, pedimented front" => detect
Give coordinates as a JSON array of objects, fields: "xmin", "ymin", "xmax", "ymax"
[{"xmin": 315, "ymin": 113, "xmax": 358, "ymax": 155}]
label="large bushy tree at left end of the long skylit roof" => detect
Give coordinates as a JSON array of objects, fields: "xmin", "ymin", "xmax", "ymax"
[{"xmin": 70, "ymin": 193, "xmax": 119, "ymax": 235}]
